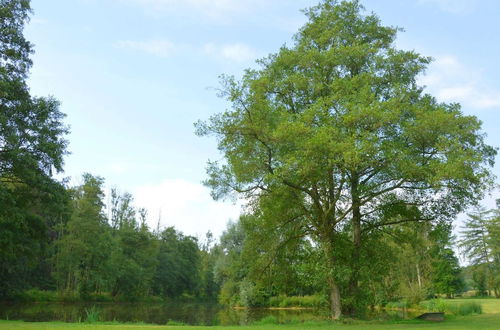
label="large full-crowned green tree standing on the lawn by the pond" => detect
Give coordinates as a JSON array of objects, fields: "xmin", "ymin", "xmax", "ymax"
[{"xmin": 197, "ymin": 0, "xmax": 496, "ymax": 318}]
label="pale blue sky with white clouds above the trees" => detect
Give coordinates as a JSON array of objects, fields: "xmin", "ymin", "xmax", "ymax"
[{"xmin": 25, "ymin": 0, "xmax": 500, "ymax": 236}]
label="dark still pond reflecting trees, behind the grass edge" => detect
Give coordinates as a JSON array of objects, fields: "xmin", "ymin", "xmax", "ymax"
[{"xmin": 0, "ymin": 302, "xmax": 422, "ymax": 325}]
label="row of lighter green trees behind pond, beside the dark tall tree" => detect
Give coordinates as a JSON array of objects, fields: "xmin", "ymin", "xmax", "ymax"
[{"xmin": 53, "ymin": 174, "xmax": 212, "ymax": 300}]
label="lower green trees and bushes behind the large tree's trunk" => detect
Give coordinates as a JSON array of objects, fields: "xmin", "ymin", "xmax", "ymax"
[{"xmin": 216, "ymin": 216, "xmax": 465, "ymax": 306}]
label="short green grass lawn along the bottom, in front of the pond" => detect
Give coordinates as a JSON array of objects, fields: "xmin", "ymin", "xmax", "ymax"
[{"xmin": 0, "ymin": 299, "xmax": 500, "ymax": 330}]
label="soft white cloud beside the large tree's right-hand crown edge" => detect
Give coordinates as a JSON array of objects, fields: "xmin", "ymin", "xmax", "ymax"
[{"xmin": 419, "ymin": 55, "xmax": 500, "ymax": 109}]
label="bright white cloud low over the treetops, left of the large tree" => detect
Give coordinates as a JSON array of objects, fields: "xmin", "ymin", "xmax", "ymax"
[{"xmin": 133, "ymin": 179, "xmax": 241, "ymax": 237}]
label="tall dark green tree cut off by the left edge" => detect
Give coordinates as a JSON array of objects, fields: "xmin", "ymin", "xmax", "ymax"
[{"xmin": 0, "ymin": 0, "xmax": 68, "ymax": 299}]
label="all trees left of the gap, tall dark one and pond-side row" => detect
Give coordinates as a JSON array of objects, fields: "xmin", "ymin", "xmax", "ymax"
[{"xmin": 0, "ymin": 0, "xmax": 217, "ymax": 299}]
